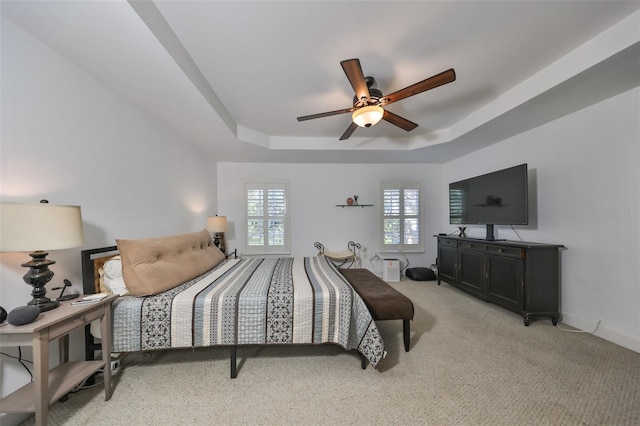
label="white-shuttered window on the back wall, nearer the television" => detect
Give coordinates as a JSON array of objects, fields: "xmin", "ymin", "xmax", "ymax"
[{"xmin": 381, "ymin": 182, "xmax": 423, "ymax": 252}]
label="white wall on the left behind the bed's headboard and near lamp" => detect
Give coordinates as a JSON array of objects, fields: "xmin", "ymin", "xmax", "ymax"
[{"xmin": 0, "ymin": 19, "xmax": 216, "ymax": 424}]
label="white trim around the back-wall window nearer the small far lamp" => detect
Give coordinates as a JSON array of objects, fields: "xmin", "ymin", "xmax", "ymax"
[{"xmin": 242, "ymin": 180, "xmax": 291, "ymax": 255}]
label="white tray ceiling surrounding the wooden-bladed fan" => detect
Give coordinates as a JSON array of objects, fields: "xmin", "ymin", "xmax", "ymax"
[{"xmin": 1, "ymin": 0, "xmax": 640, "ymax": 163}]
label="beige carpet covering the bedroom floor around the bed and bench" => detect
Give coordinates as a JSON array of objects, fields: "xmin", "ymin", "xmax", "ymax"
[{"xmin": 17, "ymin": 281, "xmax": 640, "ymax": 425}]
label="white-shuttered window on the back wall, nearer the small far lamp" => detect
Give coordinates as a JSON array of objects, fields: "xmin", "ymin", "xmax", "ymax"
[{"xmin": 245, "ymin": 182, "xmax": 289, "ymax": 254}]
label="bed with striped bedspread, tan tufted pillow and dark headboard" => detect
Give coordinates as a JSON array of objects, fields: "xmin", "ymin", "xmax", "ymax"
[{"xmin": 82, "ymin": 230, "xmax": 386, "ymax": 378}]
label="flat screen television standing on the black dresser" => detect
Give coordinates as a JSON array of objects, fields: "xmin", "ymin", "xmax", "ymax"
[{"xmin": 449, "ymin": 163, "xmax": 529, "ymax": 240}]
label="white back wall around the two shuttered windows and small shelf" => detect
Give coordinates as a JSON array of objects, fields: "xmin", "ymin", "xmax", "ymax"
[{"xmin": 218, "ymin": 163, "xmax": 442, "ymax": 272}]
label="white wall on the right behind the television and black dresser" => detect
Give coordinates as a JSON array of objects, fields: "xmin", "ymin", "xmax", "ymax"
[{"xmin": 438, "ymin": 88, "xmax": 640, "ymax": 352}]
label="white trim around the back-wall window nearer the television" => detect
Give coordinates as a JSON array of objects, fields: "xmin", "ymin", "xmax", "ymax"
[{"xmin": 378, "ymin": 180, "xmax": 424, "ymax": 253}]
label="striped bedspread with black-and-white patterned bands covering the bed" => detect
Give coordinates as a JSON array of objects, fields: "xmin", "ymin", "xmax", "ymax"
[{"xmin": 113, "ymin": 256, "xmax": 385, "ymax": 367}]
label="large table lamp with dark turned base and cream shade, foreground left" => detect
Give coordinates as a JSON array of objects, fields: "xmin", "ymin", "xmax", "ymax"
[{"xmin": 0, "ymin": 200, "xmax": 84, "ymax": 312}]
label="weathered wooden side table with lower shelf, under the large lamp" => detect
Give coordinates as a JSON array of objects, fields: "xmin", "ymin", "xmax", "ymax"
[{"xmin": 0, "ymin": 295, "xmax": 118, "ymax": 425}]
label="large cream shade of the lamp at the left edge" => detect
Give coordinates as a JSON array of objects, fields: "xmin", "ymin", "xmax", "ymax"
[{"xmin": 0, "ymin": 202, "xmax": 84, "ymax": 251}]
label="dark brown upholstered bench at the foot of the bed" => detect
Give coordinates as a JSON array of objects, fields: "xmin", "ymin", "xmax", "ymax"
[{"xmin": 340, "ymin": 269, "xmax": 413, "ymax": 352}]
